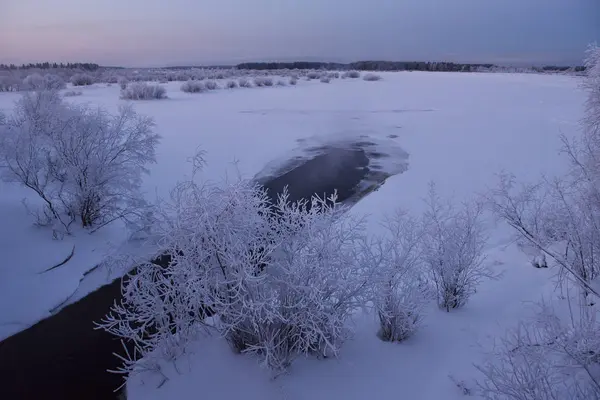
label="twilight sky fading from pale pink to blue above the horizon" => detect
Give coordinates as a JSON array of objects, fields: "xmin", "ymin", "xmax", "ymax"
[{"xmin": 0, "ymin": 0, "xmax": 600, "ymax": 67}]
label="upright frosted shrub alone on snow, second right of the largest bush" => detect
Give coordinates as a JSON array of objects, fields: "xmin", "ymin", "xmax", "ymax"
[{"xmin": 423, "ymin": 184, "xmax": 494, "ymax": 311}]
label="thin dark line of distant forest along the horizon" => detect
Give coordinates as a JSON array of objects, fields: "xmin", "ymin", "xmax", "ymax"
[{"xmin": 0, "ymin": 61, "xmax": 585, "ymax": 72}]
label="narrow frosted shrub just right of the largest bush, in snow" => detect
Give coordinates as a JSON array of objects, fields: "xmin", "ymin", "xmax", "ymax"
[{"xmin": 375, "ymin": 211, "xmax": 427, "ymax": 342}]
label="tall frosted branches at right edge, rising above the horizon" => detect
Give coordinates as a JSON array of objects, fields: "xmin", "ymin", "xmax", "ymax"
[{"xmin": 489, "ymin": 48, "xmax": 600, "ymax": 297}]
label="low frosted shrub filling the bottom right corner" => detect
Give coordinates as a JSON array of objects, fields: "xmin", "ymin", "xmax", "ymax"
[{"xmin": 477, "ymin": 307, "xmax": 600, "ymax": 400}]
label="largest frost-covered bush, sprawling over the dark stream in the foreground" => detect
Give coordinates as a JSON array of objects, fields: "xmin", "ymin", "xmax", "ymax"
[{"xmin": 102, "ymin": 158, "xmax": 378, "ymax": 371}]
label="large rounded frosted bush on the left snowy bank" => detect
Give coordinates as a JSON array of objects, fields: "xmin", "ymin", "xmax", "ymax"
[{"xmin": 0, "ymin": 91, "xmax": 158, "ymax": 232}]
